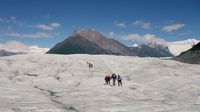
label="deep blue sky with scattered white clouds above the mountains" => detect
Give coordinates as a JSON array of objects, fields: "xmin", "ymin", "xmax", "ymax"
[{"xmin": 0, "ymin": 0, "xmax": 200, "ymax": 48}]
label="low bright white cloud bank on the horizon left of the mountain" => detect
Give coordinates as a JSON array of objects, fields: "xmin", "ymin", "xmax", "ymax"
[{"xmin": 0, "ymin": 40, "xmax": 49, "ymax": 54}]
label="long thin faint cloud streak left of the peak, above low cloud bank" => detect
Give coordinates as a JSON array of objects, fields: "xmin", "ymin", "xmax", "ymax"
[{"xmin": 6, "ymin": 32, "xmax": 53, "ymax": 38}]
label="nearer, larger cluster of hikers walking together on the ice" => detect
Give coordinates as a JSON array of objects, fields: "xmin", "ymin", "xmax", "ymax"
[{"xmin": 104, "ymin": 73, "xmax": 122, "ymax": 86}]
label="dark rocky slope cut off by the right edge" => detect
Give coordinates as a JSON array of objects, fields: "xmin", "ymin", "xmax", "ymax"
[{"xmin": 173, "ymin": 42, "xmax": 200, "ymax": 64}]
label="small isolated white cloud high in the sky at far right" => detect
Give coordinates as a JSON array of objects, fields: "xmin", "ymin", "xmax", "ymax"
[{"xmin": 162, "ymin": 24, "xmax": 185, "ymax": 32}]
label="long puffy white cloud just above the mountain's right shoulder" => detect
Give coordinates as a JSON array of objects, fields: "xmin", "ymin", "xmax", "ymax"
[{"xmin": 122, "ymin": 33, "xmax": 165, "ymax": 43}]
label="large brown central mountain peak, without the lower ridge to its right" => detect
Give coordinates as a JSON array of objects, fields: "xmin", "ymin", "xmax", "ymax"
[{"xmin": 47, "ymin": 29, "xmax": 131, "ymax": 55}]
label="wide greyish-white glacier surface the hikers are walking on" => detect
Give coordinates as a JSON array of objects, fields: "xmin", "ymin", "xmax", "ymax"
[{"xmin": 0, "ymin": 54, "xmax": 200, "ymax": 112}]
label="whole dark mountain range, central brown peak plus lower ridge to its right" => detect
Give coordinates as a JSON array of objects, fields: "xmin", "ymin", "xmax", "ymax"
[{"xmin": 47, "ymin": 29, "xmax": 172, "ymax": 57}]
